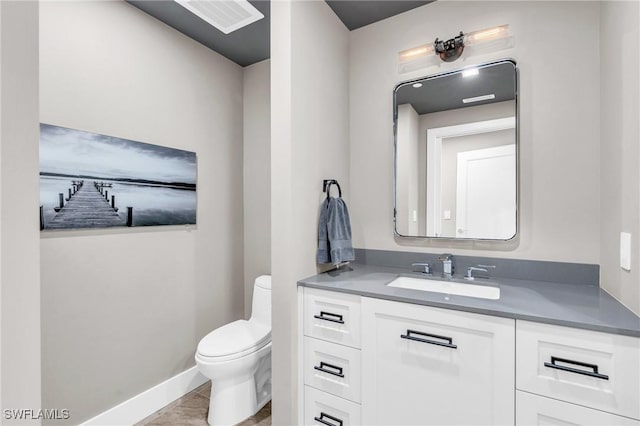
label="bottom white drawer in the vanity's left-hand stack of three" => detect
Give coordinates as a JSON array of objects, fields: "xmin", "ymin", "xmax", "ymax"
[{"xmin": 304, "ymin": 386, "xmax": 360, "ymax": 426}]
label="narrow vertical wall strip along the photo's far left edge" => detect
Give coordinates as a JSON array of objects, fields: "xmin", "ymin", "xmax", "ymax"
[{"xmin": 0, "ymin": 2, "xmax": 41, "ymax": 425}]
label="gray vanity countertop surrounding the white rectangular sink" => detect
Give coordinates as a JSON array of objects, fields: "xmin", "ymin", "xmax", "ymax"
[{"xmin": 298, "ymin": 264, "xmax": 640, "ymax": 337}]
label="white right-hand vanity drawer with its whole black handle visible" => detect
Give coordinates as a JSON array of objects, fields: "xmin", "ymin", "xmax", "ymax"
[{"xmin": 516, "ymin": 320, "xmax": 640, "ymax": 419}]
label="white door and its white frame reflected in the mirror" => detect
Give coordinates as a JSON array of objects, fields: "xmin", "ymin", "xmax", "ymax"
[{"xmin": 425, "ymin": 116, "xmax": 516, "ymax": 240}]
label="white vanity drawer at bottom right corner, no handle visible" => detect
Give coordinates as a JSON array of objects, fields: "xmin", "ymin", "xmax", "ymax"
[{"xmin": 516, "ymin": 391, "xmax": 640, "ymax": 426}]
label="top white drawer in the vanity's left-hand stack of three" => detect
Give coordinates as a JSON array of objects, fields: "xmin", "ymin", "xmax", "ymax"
[{"xmin": 304, "ymin": 288, "xmax": 360, "ymax": 348}]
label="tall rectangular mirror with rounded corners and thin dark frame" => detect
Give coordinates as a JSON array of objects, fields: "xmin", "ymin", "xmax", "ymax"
[{"xmin": 393, "ymin": 60, "xmax": 518, "ymax": 240}]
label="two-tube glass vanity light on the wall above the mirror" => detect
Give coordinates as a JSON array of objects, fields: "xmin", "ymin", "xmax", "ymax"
[{"xmin": 398, "ymin": 25, "xmax": 514, "ymax": 73}]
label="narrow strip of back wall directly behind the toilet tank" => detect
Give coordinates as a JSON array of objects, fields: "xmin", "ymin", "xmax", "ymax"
[{"xmin": 243, "ymin": 60, "xmax": 271, "ymax": 318}]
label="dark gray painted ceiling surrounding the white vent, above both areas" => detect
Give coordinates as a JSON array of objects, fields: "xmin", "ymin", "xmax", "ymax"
[{"xmin": 127, "ymin": 0, "xmax": 433, "ymax": 67}]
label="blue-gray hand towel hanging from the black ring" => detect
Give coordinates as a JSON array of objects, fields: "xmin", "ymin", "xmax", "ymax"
[{"xmin": 317, "ymin": 197, "xmax": 355, "ymax": 265}]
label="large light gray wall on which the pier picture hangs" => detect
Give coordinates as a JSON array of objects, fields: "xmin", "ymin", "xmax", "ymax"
[{"xmin": 40, "ymin": 2, "xmax": 244, "ymax": 424}]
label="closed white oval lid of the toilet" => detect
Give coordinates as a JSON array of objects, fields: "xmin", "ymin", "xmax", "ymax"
[{"xmin": 198, "ymin": 320, "xmax": 271, "ymax": 357}]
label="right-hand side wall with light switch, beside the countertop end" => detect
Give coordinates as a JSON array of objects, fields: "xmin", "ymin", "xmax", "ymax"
[{"xmin": 600, "ymin": 1, "xmax": 640, "ymax": 315}]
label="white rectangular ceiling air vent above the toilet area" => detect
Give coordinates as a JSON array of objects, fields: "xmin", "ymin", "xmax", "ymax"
[{"xmin": 175, "ymin": 0, "xmax": 264, "ymax": 34}]
